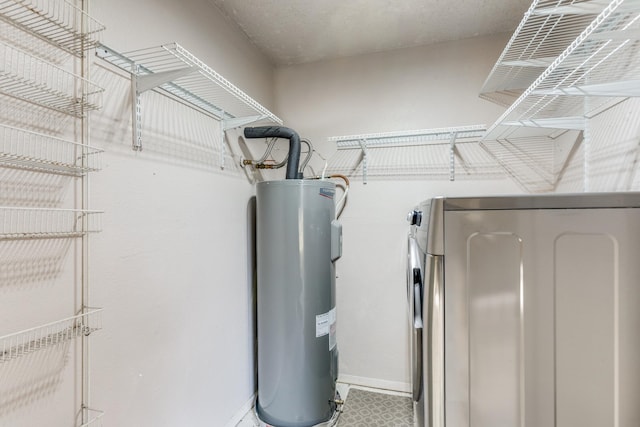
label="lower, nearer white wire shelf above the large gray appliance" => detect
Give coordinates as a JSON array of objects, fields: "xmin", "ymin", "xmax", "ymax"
[{"xmin": 485, "ymin": 0, "xmax": 640, "ymax": 140}]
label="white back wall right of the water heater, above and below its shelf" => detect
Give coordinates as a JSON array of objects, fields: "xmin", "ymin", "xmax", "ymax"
[{"xmin": 275, "ymin": 34, "xmax": 521, "ymax": 391}]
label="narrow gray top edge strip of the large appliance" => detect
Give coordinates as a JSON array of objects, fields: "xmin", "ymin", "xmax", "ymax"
[{"xmin": 443, "ymin": 192, "xmax": 640, "ymax": 211}]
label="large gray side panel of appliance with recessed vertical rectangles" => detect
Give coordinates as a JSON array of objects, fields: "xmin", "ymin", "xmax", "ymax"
[{"xmin": 440, "ymin": 208, "xmax": 640, "ymax": 427}]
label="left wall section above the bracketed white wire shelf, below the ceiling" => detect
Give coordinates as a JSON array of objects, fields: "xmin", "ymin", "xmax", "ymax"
[{"xmin": 91, "ymin": 0, "xmax": 273, "ymax": 108}]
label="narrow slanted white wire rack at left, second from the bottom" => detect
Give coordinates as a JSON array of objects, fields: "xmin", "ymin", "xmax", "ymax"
[{"xmin": 0, "ymin": 308, "xmax": 102, "ymax": 363}]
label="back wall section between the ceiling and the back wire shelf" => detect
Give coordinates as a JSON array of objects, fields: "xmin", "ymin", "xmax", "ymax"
[{"xmin": 275, "ymin": 34, "xmax": 509, "ymax": 144}]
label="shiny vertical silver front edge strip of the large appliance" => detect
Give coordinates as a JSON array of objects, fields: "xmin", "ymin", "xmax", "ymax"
[{"xmin": 423, "ymin": 254, "xmax": 445, "ymax": 427}]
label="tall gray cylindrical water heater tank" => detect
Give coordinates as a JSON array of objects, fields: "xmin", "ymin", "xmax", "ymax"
[{"xmin": 256, "ymin": 180, "xmax": 338, "ymax": 427}]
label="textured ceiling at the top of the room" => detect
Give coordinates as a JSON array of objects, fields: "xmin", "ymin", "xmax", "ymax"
[{"xmin": 209, "ymin": 0, "xmax": 531, "ymax": 65}]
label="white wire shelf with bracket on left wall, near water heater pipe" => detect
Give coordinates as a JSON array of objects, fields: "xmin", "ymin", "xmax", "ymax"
[{"xmin": 96, "ymin": 43, "xmax": 282, "ymax": 150}]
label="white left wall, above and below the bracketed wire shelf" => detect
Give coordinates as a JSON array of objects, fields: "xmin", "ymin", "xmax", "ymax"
[{"xmin": 89, "ymin": 0, "xmax": 273, "ymax": 426}]
